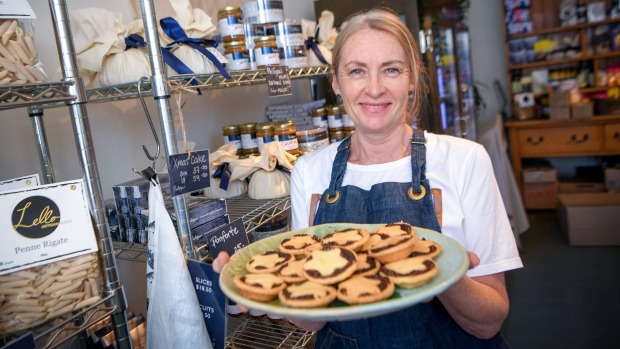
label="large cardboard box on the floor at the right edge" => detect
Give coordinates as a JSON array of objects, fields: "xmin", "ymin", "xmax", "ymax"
[{"xmin": 558, "ymin": 193, "xmax": 620, "ymax": 246}]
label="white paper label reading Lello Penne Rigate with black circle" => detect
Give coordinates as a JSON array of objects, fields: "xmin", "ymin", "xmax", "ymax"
[{"xmin": 0, "ymin": 180, "xmax": 97, "ymax": 275}]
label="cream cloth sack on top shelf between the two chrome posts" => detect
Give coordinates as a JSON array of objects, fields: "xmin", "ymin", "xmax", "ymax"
[{"xmin": 72, "ymin": 8, "xmax": 151, "ymax": 88}]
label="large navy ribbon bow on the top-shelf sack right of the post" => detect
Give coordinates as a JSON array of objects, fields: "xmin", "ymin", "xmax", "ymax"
[{"xmin": 159, "ymin": 17, "xmax": 232, "ymax": 79}]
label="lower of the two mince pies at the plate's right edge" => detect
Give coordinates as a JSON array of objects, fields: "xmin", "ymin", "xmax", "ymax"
[{"xmin": 381, "ymin": 257, "xmax": 438, "ymax": 288}]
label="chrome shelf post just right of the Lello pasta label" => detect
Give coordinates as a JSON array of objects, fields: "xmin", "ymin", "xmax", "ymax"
[{"xmin": 49, "ymin": 0, "xmax": 131, "ymax": 348}]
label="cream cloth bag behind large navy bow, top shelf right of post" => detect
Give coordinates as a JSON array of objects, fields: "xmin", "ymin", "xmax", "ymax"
[{"xmin": 159, "ymin": 0, "xmax": 227, "ymax": 76}]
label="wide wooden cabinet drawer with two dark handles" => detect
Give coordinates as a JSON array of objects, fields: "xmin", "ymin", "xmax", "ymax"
[{"xmin": 519, "ymin": 126, "xmax": 603, "ymax": 157}]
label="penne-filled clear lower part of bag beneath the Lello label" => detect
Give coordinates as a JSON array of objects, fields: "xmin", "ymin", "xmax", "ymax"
[{"xmin": 0, "ymin": 252, "xmax": 102, "ymax": 336}]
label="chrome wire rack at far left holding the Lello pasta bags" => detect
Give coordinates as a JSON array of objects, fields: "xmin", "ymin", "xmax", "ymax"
[{"xmin": 0, "ymin": 0, "xmax": 131, "ymax": 348}]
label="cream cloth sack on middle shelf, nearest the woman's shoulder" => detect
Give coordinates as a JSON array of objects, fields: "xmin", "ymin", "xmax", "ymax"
[{"xmin": 230, "ymin": 142, "xmax": 295, "ymax": 200}]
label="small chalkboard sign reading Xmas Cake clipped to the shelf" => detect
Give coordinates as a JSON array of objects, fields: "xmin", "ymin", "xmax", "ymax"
[{"xmin": 168, "ymin": 149, "xmax": 211, "ymax": 196}]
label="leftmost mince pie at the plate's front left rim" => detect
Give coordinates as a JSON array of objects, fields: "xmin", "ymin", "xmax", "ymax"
[{"xmin": 233, "ymin": 274, "xmax": 286, "ymax": 302}]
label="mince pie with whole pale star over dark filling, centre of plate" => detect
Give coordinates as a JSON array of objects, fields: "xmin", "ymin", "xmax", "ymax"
[{"xmin": 304, "ymin": 247, "xmax": 357, "ymax": 285}]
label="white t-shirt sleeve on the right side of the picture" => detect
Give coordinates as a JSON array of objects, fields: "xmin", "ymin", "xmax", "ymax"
[{"xmin": 459, "ymin": 146, "xmax": 523, "ymax": 276}]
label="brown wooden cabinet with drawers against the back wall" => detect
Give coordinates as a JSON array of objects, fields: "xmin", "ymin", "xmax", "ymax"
[{"xmin": 506, "ymin": 115, "xmax": 620, "ymax": 208}]
